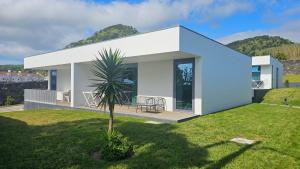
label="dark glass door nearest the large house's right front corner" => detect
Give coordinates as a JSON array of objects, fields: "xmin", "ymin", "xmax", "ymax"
[{"xmin": 174, "ymin": 59, "xmax": 194, "ymax": 110}]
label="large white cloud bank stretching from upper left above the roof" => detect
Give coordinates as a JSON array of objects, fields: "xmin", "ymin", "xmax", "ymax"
[{"xmin": 0, "ymin": 0, "xmax": 251, "ymax": 63}]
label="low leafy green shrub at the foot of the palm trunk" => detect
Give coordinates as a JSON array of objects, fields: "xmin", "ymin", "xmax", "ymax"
[{"xmin": 101, "ymin": 131, "xmax": 133, "ymax": 161}]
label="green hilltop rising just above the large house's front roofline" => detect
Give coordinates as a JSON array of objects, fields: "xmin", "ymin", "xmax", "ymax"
[{"xmin": 65, "ymin": 24, "xmax": 139, "ymax": 48}]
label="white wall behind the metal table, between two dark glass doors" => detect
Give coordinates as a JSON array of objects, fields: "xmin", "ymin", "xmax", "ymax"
[{"xmin": 138, "ymin": 60, "xmax": 173, "ymax": 111}]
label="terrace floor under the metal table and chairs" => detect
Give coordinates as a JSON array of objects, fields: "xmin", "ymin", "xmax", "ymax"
[{"xmin": 80, "ymin": 105, "xmax": 199, "ymax": 123}]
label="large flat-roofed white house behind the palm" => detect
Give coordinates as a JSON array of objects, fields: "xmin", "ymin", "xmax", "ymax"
[{"xmin": 24, "ymin": 26, "xmax": 252, "ymax": 115}]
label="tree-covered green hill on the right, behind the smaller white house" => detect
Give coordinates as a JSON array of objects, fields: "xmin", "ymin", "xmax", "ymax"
[{"xmin": 227, "ymin": 35, "xmax": 294, "ymax": 60}]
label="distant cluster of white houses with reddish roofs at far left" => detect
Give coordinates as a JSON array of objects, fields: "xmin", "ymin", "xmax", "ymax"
[{"xmin": 0, "ymin": 70, "xmax": 47, "ymax": 83}]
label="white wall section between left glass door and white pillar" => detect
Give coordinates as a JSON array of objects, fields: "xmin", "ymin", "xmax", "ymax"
[{"xmin": 56, "ymin": 69, "xmax": 71, "ymax": 92}]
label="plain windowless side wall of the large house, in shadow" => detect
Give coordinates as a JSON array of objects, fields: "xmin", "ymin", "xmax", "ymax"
[{"xmin": 180, "ymin": 28, "xmax": 252, "ymax": 114}]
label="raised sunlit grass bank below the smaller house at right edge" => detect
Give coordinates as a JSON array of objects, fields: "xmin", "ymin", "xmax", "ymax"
[{"xmin": 262, "ymin": 88, "xmax": 300, "ymax": 106}]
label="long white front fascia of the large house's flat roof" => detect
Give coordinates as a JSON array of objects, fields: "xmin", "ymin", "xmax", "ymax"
[{"xmin": 24, "ymin": 27, "xmax": 180, "ymax": 69}]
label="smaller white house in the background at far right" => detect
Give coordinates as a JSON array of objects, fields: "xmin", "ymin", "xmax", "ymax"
[{"xmin": 252, "ymin": 55, "xmax": 283, "ymax": 89}]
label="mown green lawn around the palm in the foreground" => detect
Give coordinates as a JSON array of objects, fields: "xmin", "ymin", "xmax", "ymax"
[{"xmin": 0, "ymin": 104, "xmax": 300, "ymax": 169}]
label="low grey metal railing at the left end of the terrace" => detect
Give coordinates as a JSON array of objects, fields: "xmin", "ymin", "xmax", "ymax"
[{"xmin": 24, "ymin": 89, "xmax": 57, "ymax": 104}]
